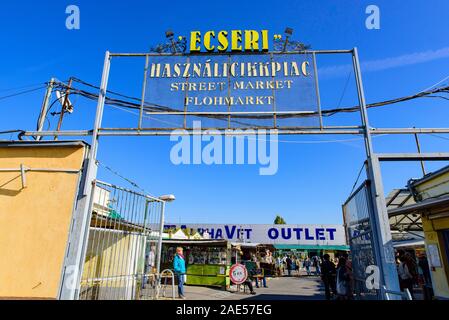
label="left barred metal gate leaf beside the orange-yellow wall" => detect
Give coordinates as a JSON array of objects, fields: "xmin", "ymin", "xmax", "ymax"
[{"xmin": 79, "ymin": 181, "xmax": 165, "ymax": 300}]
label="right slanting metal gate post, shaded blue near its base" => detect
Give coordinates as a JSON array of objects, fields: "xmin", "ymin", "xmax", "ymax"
[{"xmin": 353, "ymin": 48, "xmax": 399, "ymax": 299}]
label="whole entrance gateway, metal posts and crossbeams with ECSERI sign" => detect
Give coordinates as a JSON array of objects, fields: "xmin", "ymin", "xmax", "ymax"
[{"xmin": 23, "ymin": 28, "xmax": 449, "ymax": 299}]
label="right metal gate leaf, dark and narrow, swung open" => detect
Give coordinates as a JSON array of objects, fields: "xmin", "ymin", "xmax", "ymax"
[{"xmin": 343, "ymin": 181, "xmax": 380, "ymax": 299}]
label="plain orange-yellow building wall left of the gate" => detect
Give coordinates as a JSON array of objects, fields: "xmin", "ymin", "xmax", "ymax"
[{"xmin": 0, "ymin": 145, "xmax": 85, "ymax": 299}]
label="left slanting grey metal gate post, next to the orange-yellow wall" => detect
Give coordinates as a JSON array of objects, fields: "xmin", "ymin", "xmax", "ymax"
[{"xmin": 59, "ymin": 51, "xmax": 111, "ymax": 300}]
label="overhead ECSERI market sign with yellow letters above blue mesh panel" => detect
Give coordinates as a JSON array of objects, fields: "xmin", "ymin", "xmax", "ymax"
[{"xmin": 144, "ymin": 30, "xmax": 319, "ymax": 129}]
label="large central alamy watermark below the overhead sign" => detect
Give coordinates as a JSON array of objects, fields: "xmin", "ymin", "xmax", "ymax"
[{"xmin": 170, "ymin": 121, "xmax": 279, "ymax": 176}]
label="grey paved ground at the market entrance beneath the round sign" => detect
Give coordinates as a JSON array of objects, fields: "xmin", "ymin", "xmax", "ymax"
[{"xmin": 179, "ymin": 277, "xmax": 324, "ymax": 300}]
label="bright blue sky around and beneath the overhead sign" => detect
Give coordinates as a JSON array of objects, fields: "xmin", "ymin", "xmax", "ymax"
[{"xmin": 0, "ymin": 0, "xmax": 449, "ymax": 224}]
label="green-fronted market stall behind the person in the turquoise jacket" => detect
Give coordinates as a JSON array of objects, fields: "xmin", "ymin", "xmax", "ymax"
[{"xmin": 161, "ymin": 240, "xmax": 232, "ymax": 288}]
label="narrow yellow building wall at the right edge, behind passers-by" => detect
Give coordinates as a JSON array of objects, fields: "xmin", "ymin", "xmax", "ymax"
[{"xmin": 422, "ymin": 217, "xmax": 449, "ymax": 299}]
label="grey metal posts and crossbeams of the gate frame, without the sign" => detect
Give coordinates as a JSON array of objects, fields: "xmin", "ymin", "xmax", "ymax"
[{"xmin": 23, "ymin": 48, "xmax": 449, "ymax": 300}]
